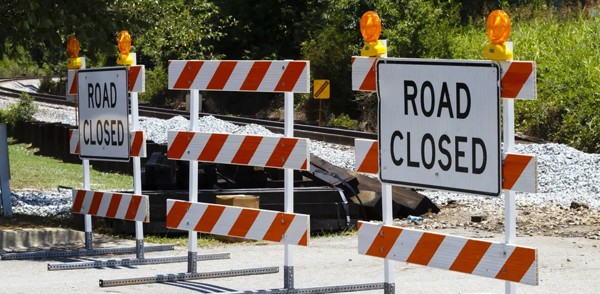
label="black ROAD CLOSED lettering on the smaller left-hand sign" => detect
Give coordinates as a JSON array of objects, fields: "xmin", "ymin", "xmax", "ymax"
[{"xmin": 81, "ymin": 83, "xmax": 128, "ymax": 146}]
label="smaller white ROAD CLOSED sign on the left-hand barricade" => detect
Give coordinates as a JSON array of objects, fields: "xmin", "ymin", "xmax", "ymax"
[{"xmin": 77, "ymin": 67, "xmax": 130, "ymax": 161}]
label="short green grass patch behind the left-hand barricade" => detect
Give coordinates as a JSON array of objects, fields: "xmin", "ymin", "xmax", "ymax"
[{"xmin": 8, "ymin": 143, "xmax": 133, "ymax": 190}]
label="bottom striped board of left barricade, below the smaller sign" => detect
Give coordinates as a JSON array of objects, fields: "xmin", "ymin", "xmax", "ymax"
[{"xmin": 72, "ymin": 189, "xmax": 150, "ymax": 222}]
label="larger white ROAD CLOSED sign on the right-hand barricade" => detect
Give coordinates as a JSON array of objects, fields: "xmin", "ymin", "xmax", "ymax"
[{"xmin": 377, "ymin": 58, "xmax": 502, "ymax": 196}]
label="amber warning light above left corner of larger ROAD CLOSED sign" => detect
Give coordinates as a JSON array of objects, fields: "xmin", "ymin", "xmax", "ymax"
[{"xmin": 360, "ymin": 11, "xmax": 387, "ymax": 57}]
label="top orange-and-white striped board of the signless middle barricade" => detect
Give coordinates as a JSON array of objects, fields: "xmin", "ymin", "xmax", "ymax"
[{"xmin": 169, "ymin": 60, "xmax": 310, "ymax": 93}]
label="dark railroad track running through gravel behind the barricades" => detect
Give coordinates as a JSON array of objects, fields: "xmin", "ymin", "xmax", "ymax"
[{"xmin": 0, "ymin": 77, "xmax": 377, "ymax": 146}]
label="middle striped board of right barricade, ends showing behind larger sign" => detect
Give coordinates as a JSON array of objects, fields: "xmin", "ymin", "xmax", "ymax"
[{"xmin": 354, "ymin": 139, "xmax": 538, "ymax": 193}]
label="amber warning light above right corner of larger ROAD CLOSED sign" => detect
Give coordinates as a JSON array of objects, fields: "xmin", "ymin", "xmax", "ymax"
[{"xmin": 483, "ymin": 10, "xmax": 513, "ymax": 61}]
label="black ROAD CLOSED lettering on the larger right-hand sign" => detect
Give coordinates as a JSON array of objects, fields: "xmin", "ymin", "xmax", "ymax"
[{"xmin": 390, "ymin": 80, "xmax": 487, "ymax": 174}]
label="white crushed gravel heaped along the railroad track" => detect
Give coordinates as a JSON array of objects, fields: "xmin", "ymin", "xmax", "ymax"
[{"xmin": 0, "ymin": 93, "xmax": 600, "ymax": 215}]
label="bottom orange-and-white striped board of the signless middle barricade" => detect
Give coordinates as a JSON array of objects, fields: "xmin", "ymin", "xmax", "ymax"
[{"xmin": 166, "ymin": 199, "xmax": 310, "ymax": 246}]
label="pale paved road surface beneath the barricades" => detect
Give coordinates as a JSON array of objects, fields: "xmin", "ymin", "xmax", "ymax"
[{"xmin": 0, "ymin": 230, "xmax": 600, "ymax": 294}]
